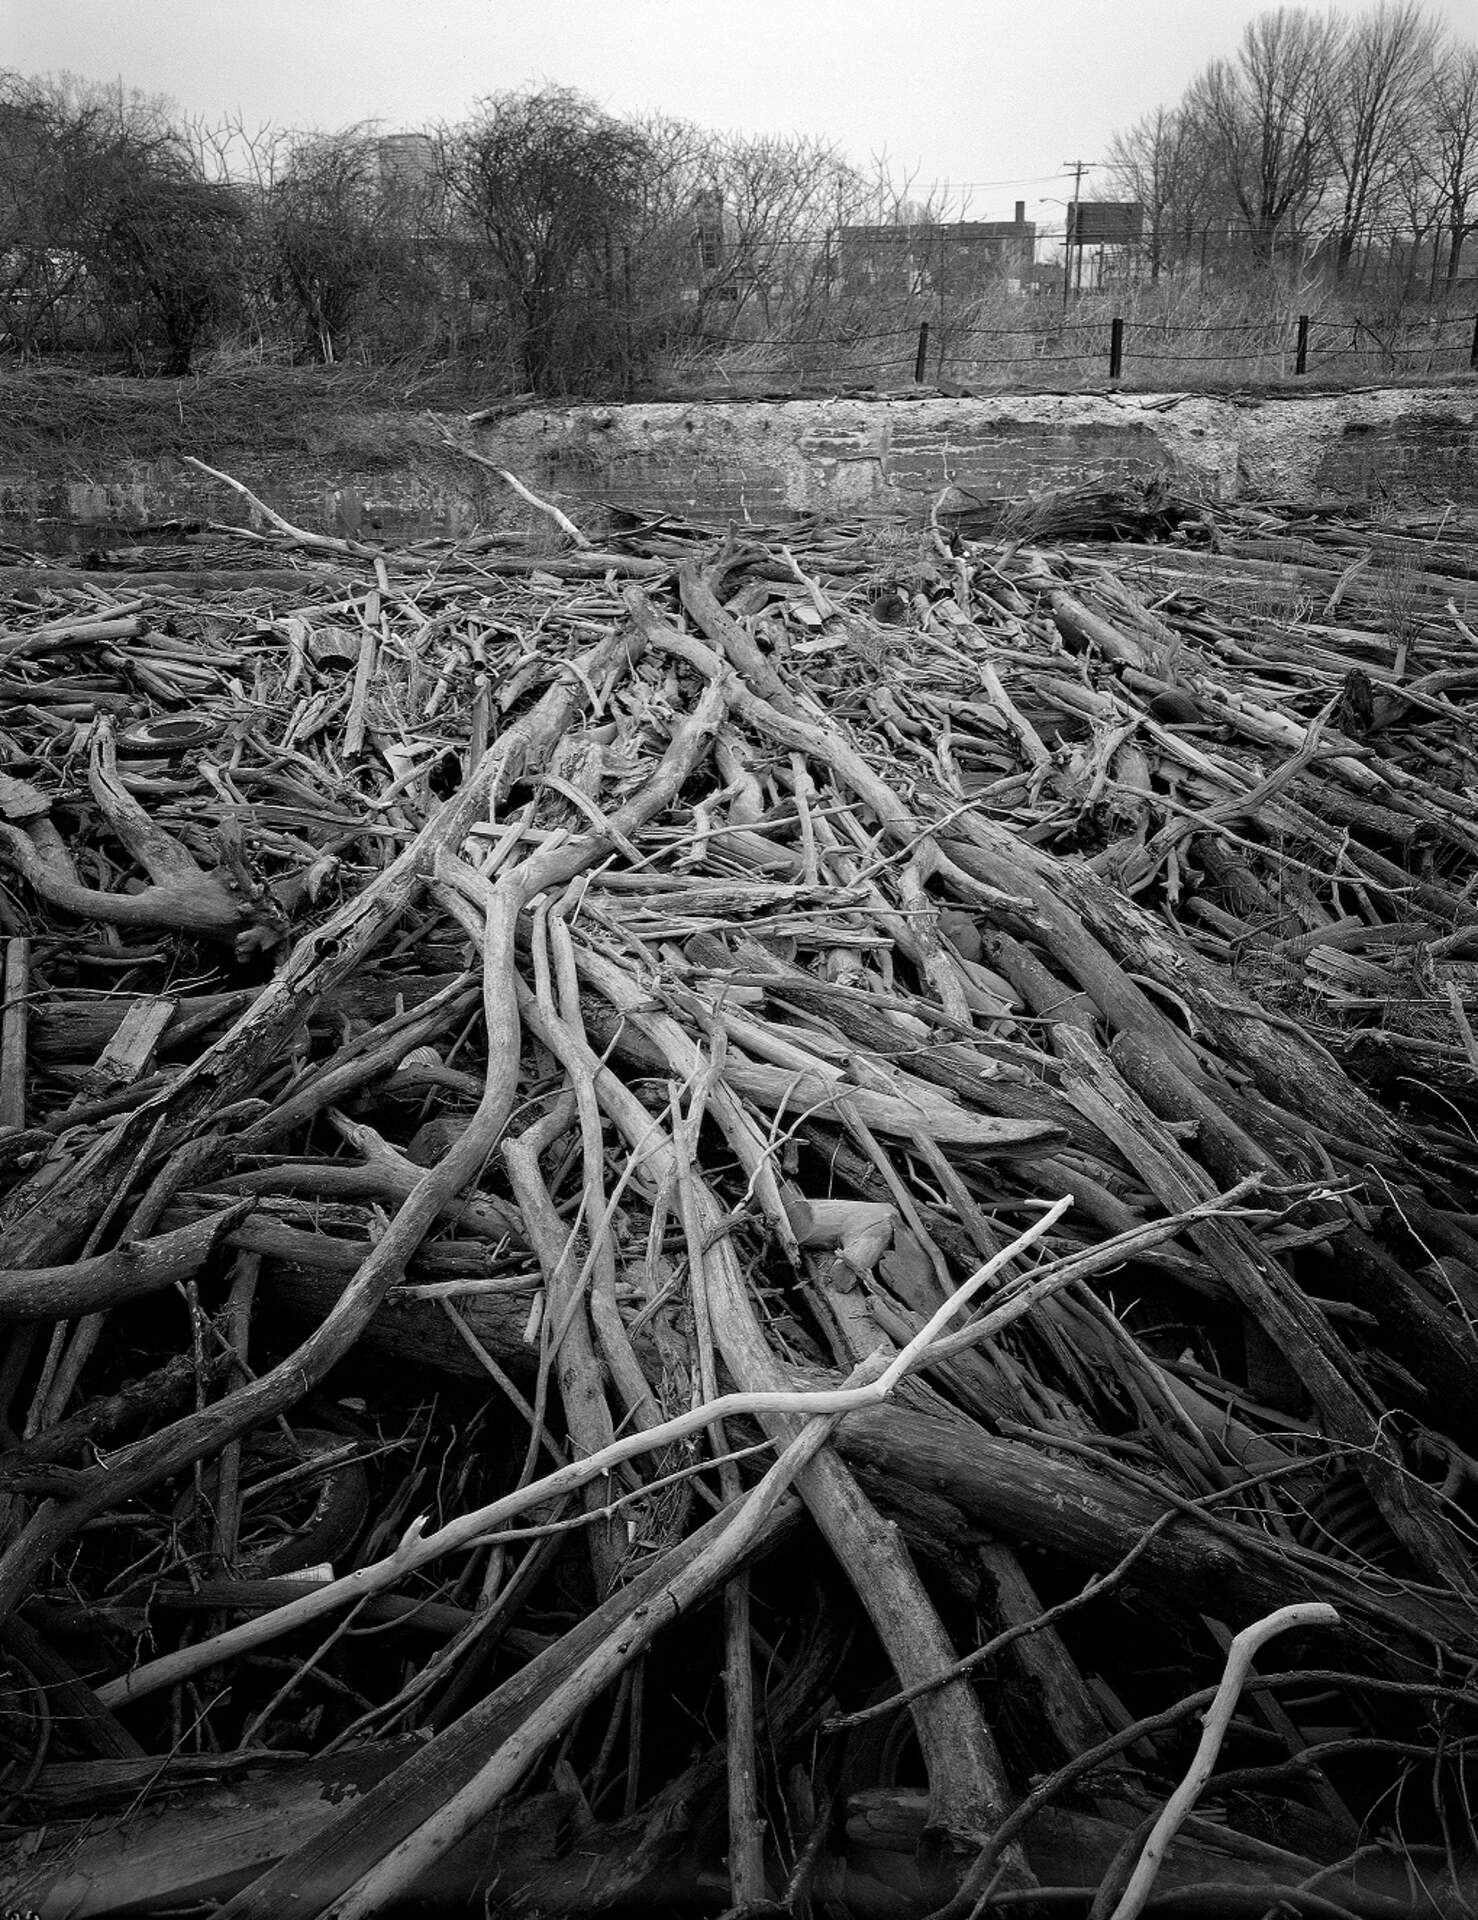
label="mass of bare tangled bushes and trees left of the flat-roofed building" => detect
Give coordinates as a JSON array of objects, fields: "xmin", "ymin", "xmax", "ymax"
[{"xmin": 0, "ymin": 71, "xmax": 921, "ymax": 392}]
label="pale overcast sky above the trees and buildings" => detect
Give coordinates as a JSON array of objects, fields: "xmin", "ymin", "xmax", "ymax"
[{"xmin": 0, "ymin": 0, "xmax": 1478, "ymax": 225}]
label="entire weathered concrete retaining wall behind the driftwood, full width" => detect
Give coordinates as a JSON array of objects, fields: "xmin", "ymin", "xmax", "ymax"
[{"xmin": 0, "ymin": 386, "xmax": 1478, "ymax": 545}]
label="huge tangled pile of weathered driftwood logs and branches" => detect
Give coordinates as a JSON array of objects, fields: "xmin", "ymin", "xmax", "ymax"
[{"xmin": 0, "ymin": 468, "xmax": 1478, "ymax": 1920}]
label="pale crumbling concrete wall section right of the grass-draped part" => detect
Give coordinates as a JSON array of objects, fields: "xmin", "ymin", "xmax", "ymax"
[{"xmin": 478, "ymin": 388, "xmax": 1478, "ymax": 520}]
